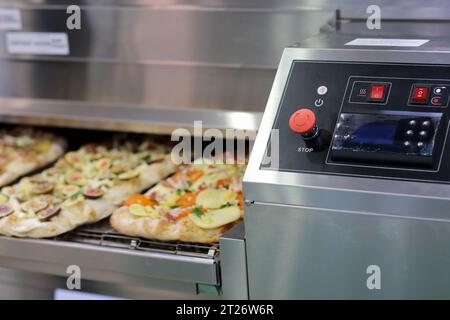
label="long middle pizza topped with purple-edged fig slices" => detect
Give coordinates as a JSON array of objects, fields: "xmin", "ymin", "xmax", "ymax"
[{"xmin": 0, "ymin": 139, "xmax": 176, "ymax": 238}]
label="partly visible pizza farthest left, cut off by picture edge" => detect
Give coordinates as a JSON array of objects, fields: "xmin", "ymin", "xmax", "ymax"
[{"xmin": 0, "ymin": 127, "xmax": 67, "ymax": 187}]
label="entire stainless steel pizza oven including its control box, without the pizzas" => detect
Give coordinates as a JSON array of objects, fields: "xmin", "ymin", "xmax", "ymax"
[{"xmin": 4, "ymin": 0, "xmax": 450, "ymax": 299}]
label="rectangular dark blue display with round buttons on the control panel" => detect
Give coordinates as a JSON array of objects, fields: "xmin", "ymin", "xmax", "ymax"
[{"xmin": 330, "ymin": 111, "xmax": 442, "ymax": 168}]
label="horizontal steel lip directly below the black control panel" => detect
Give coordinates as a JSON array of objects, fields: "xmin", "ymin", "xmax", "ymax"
[{"xmin": 244, "ymin": 180, "xmax": 450, "ymax": 222}]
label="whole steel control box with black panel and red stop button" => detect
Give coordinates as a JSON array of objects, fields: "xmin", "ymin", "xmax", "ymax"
[{"xmin": 244, "ymin": 35, "xmax": 450, "ymax": 299}]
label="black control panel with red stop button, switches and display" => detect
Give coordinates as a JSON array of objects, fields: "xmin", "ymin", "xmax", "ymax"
[{"xmin": 261, "ymin": 61, "xmax": 450, "ymax": 182}]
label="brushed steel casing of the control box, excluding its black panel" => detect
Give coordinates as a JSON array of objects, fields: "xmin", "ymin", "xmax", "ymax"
[{"xmin": 244, "ymin": 43, "xmax": 450, "ymax": 299}]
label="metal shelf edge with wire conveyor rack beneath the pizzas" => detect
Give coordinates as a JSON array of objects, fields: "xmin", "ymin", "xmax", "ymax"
[{"xmin": 0, "ymin": 221, "xmax": 220, "ymax": 286}]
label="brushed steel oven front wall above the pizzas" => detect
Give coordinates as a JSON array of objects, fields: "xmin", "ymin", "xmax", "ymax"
[{"xmin": 0, "ymin": 1, "xmax": 336, "ymax": 133}]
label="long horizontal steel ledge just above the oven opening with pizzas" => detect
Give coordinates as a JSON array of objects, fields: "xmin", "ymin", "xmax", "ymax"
[{"xmin": 0, "ymin": 98, "xmax": 261, "ymax": 134}]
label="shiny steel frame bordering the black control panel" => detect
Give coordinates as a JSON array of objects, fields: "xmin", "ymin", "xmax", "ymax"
[{"xmin": 244, "ymin": 44, "xmax": 450, "ymax": 212}]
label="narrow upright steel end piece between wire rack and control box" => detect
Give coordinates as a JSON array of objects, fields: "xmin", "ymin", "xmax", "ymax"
[{"xmin": 220, "ymin": 223, "xmax": 248, "ymax": 299}]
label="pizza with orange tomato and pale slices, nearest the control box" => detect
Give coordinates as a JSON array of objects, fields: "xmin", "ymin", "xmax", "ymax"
[{"xmin": 110, "ymin": 156, "xmax": 245, "ymax": 243}]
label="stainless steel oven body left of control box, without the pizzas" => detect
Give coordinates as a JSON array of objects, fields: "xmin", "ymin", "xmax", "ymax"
[{"xmin": 0, "ymin": 0, "xmax": 336, "ymax": 299}]
